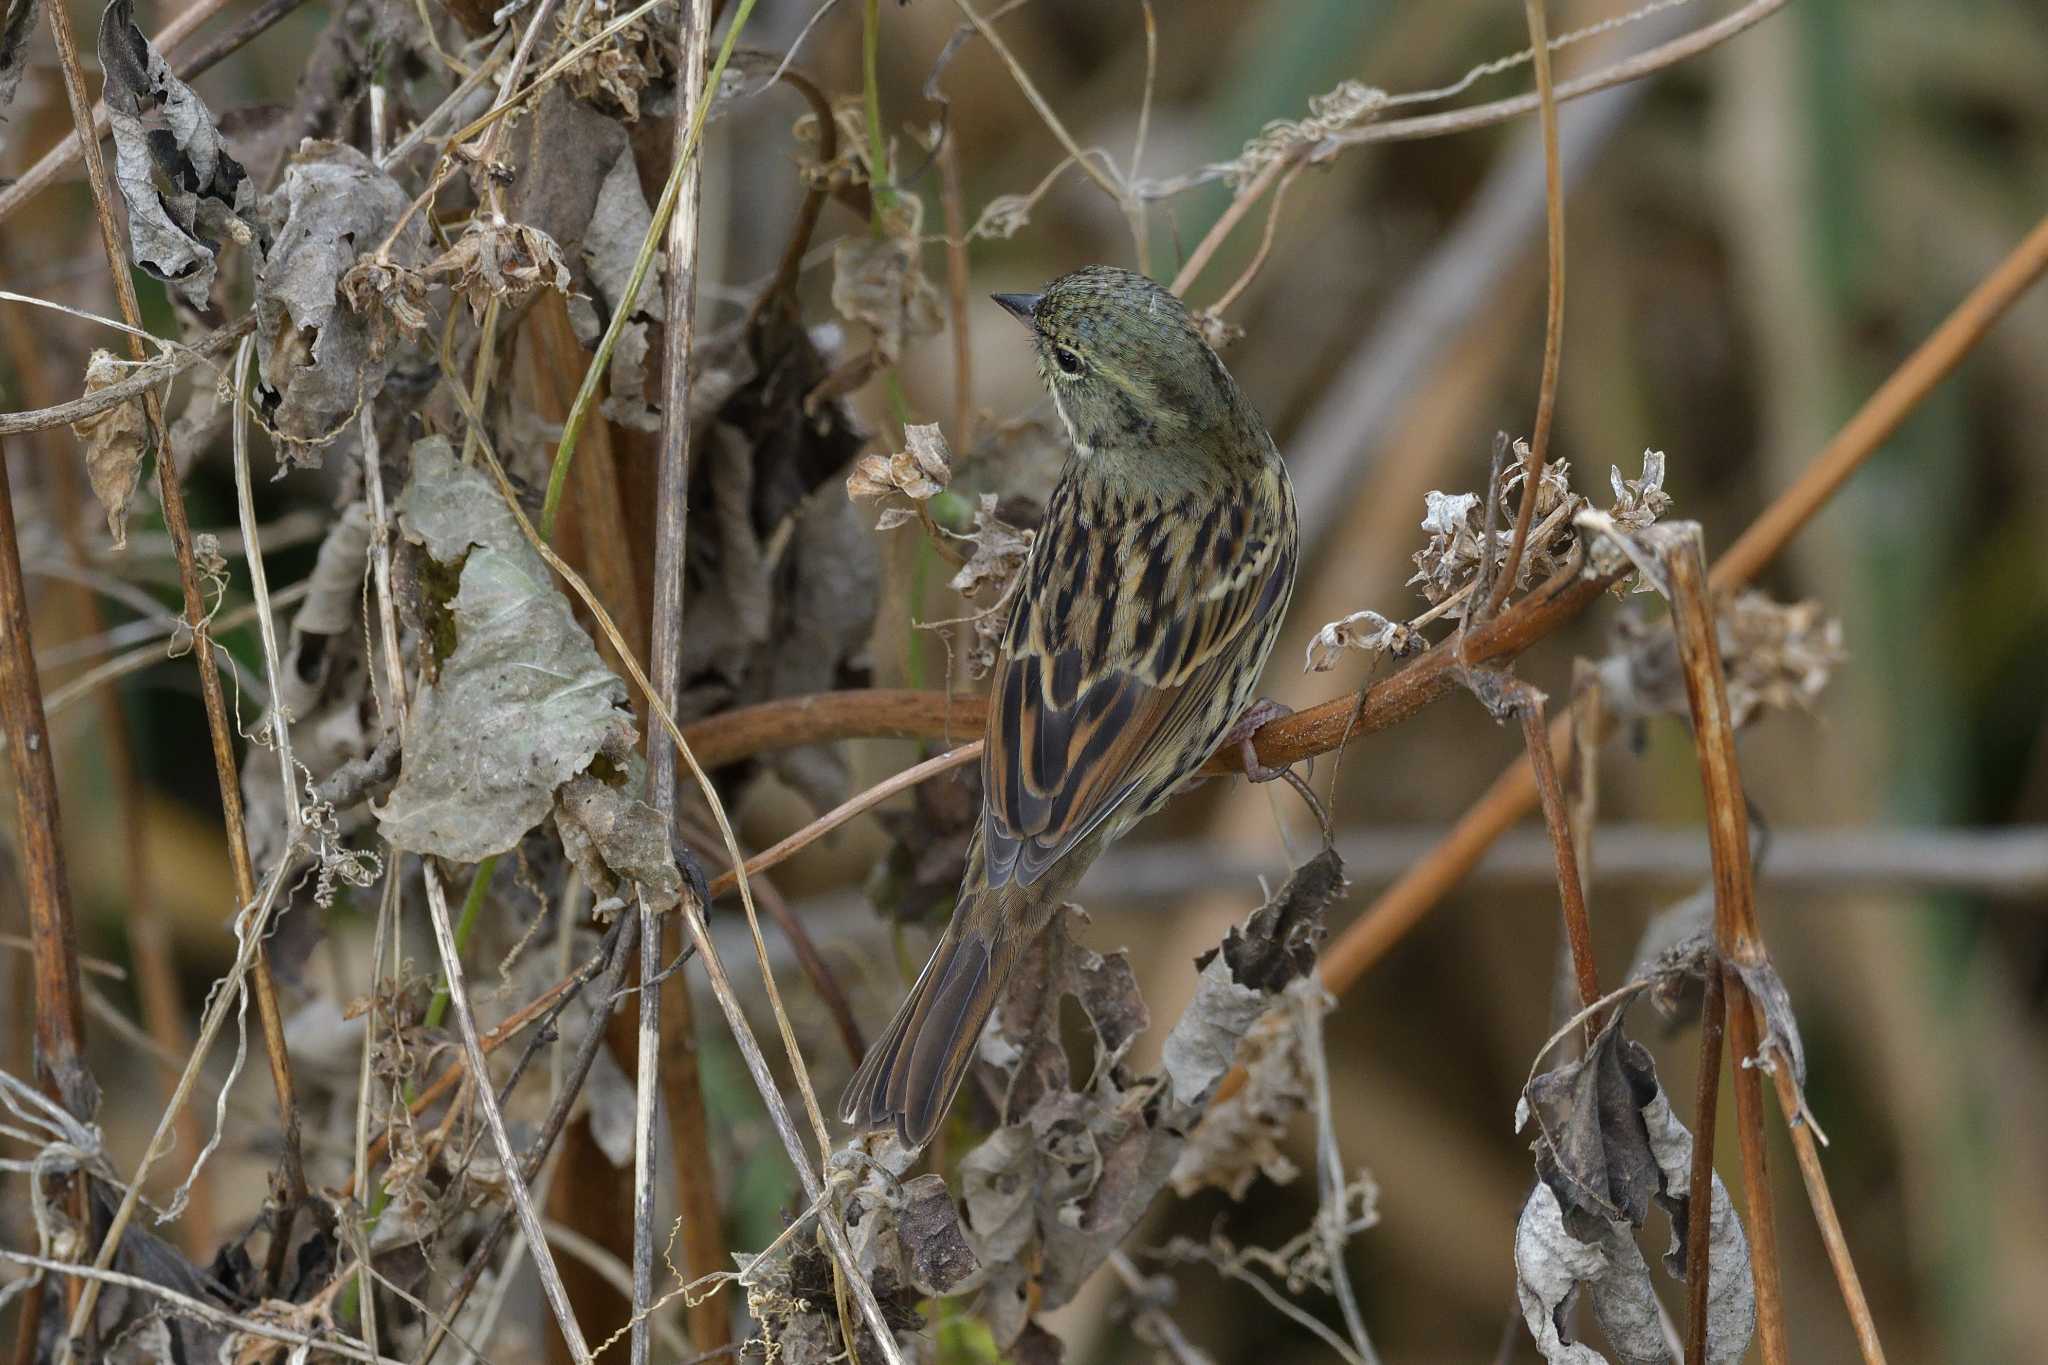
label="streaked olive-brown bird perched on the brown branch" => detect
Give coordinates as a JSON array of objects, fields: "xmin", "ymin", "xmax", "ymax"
[{"xmin": 840, "ymin": 266, "xmax": 1294, "ymax": 1146}]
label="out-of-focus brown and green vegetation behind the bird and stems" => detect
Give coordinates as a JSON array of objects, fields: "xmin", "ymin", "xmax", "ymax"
[{"xmin": 0, "ymin": 0, "xmax": 2048, "ymax": 1365}]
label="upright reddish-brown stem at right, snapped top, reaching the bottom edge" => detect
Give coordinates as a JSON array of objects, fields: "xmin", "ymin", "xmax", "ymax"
[{"xmin": 1663, "ymin": 528, "xmax": 1790, "ymax": 1365}]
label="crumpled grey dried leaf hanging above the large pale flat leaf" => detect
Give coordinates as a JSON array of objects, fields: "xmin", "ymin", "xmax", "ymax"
[{"xmin": 256, "ymin": 141, "xmax": 426, "ymax": 458}]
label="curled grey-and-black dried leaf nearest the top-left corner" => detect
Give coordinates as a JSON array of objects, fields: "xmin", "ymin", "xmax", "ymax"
[{"xmin": 100, "ymin": 0, "xmax": 256, "ymax": 307}]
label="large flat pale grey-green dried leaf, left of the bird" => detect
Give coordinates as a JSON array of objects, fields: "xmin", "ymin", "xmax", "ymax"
[{"xmin": 377, "ymin": 438, "xmax": 633, "ymax": 862}]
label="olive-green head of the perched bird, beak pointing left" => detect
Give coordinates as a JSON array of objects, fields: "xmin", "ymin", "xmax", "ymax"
[{"xmin": 995, "ymin": 266, "xmax": 1243, "ymax": 460}]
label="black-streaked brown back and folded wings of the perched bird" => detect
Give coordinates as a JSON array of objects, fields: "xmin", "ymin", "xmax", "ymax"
[{"xmin": 981, "ymin": 485, "xmax": 1292, "ymax": 886}]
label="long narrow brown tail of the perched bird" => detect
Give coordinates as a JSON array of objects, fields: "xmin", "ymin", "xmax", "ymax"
[{"xmin": 840, "ymin": 907, "xmax": 1016, "ymax": 1146}]
